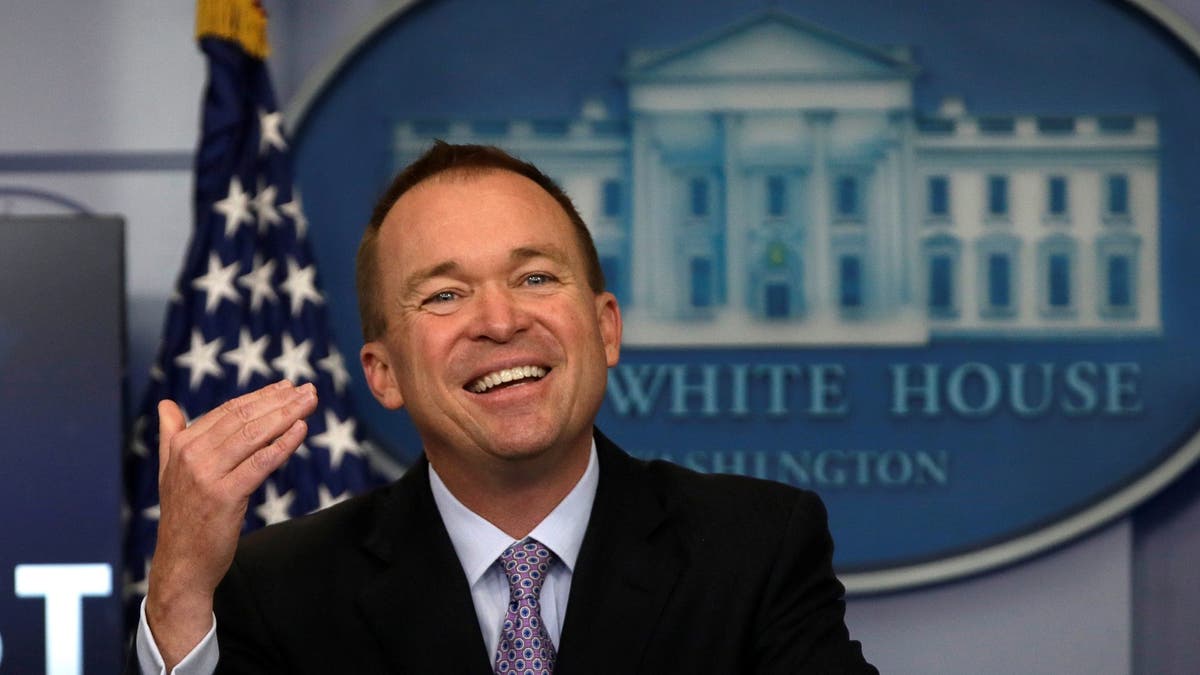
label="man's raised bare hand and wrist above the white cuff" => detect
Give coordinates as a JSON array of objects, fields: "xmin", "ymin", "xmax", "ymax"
[{"xmin": 146, "ymin": 381, "xmax": 317, "ymax": 671}]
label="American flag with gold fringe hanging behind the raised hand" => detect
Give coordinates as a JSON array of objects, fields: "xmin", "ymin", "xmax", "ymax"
[{"xmin": 125, "ymin": 1, "xmax": 383, "ymax": 625}]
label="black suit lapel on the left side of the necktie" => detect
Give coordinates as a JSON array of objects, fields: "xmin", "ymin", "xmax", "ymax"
[{"xmin": 359, "ymin": 461, "xmax": 491, "ymax": 673}]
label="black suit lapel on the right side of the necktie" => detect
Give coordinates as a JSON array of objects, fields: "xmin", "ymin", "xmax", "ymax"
[{"xmin": 554, "ymin": 431, "xmax": 688, "ymax": 675}]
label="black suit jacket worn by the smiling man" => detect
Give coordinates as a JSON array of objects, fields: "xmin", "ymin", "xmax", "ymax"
[{"xmin": 208, "ymin": 432, "xmax": 875, "ymax": 675}]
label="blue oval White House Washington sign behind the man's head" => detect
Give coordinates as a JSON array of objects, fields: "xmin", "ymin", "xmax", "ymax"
[{"xmin": 290, "ymin": 0, "xmax": 1200, "ymax": 591}]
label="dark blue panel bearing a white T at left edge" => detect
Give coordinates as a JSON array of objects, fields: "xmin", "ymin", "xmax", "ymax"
[{"xmin": 0, "ymin": 216, "xmax": 125, "ymax": 675}]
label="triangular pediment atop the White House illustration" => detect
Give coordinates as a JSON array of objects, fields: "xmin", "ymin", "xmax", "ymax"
[{"xmin": 625, "ymin": 11, "xmax": 917, "ymax": 83}]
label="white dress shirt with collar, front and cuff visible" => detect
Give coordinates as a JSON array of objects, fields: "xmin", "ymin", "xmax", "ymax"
[{"xmin": 137, "ymin": 441, "xmax": 600, "ymax": 675}]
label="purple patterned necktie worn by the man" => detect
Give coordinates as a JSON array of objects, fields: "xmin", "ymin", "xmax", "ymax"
[{"xmin": 496, "ymin": 539, "xmax": 558, "ymax": 675}]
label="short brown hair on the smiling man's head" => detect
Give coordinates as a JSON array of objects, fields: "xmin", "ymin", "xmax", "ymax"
[{"xmin": 355, "ymin": 141, "xmax": 605, "ymax": 342}]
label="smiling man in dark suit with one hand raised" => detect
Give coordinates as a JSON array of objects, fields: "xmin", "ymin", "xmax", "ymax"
[{"xmin": 138, "ymin": 143, "xmax": 875, "ymax": 675}]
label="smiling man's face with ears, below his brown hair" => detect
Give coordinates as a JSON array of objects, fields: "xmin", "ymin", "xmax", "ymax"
[{"xmin": 362, "ymin": 171, "xmax": 620, "ymax": 472}]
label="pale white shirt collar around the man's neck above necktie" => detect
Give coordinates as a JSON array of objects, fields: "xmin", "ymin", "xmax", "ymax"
[{"xmin": 428, "ymin": 440, "xmax": 600, "ymax": 586}]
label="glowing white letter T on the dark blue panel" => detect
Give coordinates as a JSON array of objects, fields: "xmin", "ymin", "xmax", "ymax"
[{"xmin": 13, "ymin": 563, "xmax": 113, "ymax": 675}]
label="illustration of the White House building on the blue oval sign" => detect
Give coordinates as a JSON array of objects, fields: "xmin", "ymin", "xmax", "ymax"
[{"xmin": 394, "ymin": 11, "xmax": 1160, "ymax": 345}]
